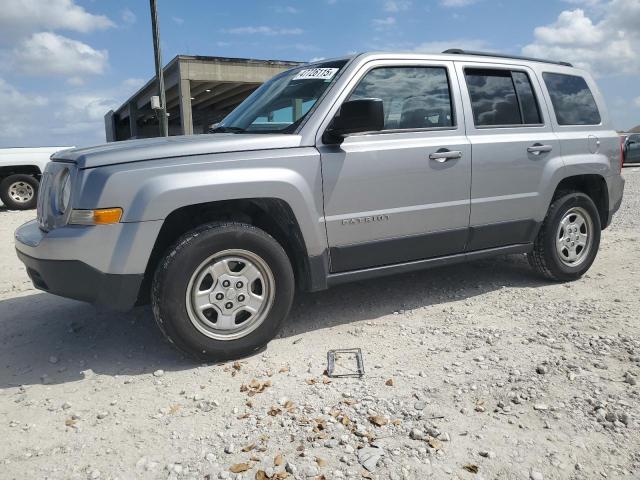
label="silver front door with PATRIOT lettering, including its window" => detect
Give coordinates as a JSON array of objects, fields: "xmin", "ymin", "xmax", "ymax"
[{"xmin": 318, "ymin": 61, "xmax": 471, "ymax": 272}]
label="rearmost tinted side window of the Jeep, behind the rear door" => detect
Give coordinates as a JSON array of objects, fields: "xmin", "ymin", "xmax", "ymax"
[{"xmin": 542, "ymin": 73, "xmax": 600, "ymax": 125}]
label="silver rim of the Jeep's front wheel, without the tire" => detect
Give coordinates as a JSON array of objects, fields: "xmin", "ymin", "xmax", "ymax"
[{"xmin": 186, "ymin": 249, "xmax": 275, "ymax": 340}]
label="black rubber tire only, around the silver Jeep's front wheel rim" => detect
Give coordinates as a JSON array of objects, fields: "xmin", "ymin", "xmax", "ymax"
[{"xmin": 151, "ymin": 223, "xmax": 295, "ymax": 361}]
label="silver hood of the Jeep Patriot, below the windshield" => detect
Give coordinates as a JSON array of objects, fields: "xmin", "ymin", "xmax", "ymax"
[{"xmin": 51, "ymin": 133, "xmax": 301, "ymax": 168}]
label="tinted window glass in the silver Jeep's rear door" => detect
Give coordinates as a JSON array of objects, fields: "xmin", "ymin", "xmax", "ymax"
[{"xmin": 465, "ymin": 68, "xmax": 542, "ymax": 127}]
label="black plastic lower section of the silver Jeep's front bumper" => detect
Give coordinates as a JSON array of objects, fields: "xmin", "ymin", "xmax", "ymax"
[{"xmin": 17, "ymin": 250, "xmax": 144, "ymax": 311}]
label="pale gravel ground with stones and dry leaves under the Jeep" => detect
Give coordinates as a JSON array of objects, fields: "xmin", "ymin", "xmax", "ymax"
[{"xmin": 0, "ymin": 168, "xmax": 640, "ymax": 480}]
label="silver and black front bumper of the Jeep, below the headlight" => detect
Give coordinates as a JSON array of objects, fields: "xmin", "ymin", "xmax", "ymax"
[{"xmin": 15, "ymin": 221, "xmax": 162, "ymax": 311}]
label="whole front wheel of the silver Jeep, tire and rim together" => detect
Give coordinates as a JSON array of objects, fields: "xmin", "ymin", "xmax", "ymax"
[{"xmin": 152, "ymin": 223, "xmax": 294, "ymax": 361}]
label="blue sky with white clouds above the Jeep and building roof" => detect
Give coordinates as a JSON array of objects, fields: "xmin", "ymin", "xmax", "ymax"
[{"xmin": 0, "ymin": 0, "xmax": 640, "ymax": 147}]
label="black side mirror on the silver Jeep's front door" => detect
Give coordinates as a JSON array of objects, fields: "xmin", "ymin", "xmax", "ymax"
[{"xmin": 323, "ymin": 98, "xmax": 384, "ymax": 143}]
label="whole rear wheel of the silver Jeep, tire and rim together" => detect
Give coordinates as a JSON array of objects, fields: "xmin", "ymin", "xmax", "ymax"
[{"xmin": 529, "ymin": 192, "xmax": 601, "ymax": 281}]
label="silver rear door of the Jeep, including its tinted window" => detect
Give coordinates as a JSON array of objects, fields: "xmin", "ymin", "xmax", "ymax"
[{"xmin": 456, "ymin": 62, "xmax": 562, "ymax": 251}]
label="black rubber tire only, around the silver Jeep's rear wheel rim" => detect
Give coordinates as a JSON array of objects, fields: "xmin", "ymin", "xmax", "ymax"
[{"xmin": 528, "ymin": 191, "xmax": 602, "ymax": 282}]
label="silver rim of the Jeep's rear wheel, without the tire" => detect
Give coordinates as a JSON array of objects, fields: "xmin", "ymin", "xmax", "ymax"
[{"xmin": 556, "ymin": 207, "xmax": 593, "ymax": 267}]
